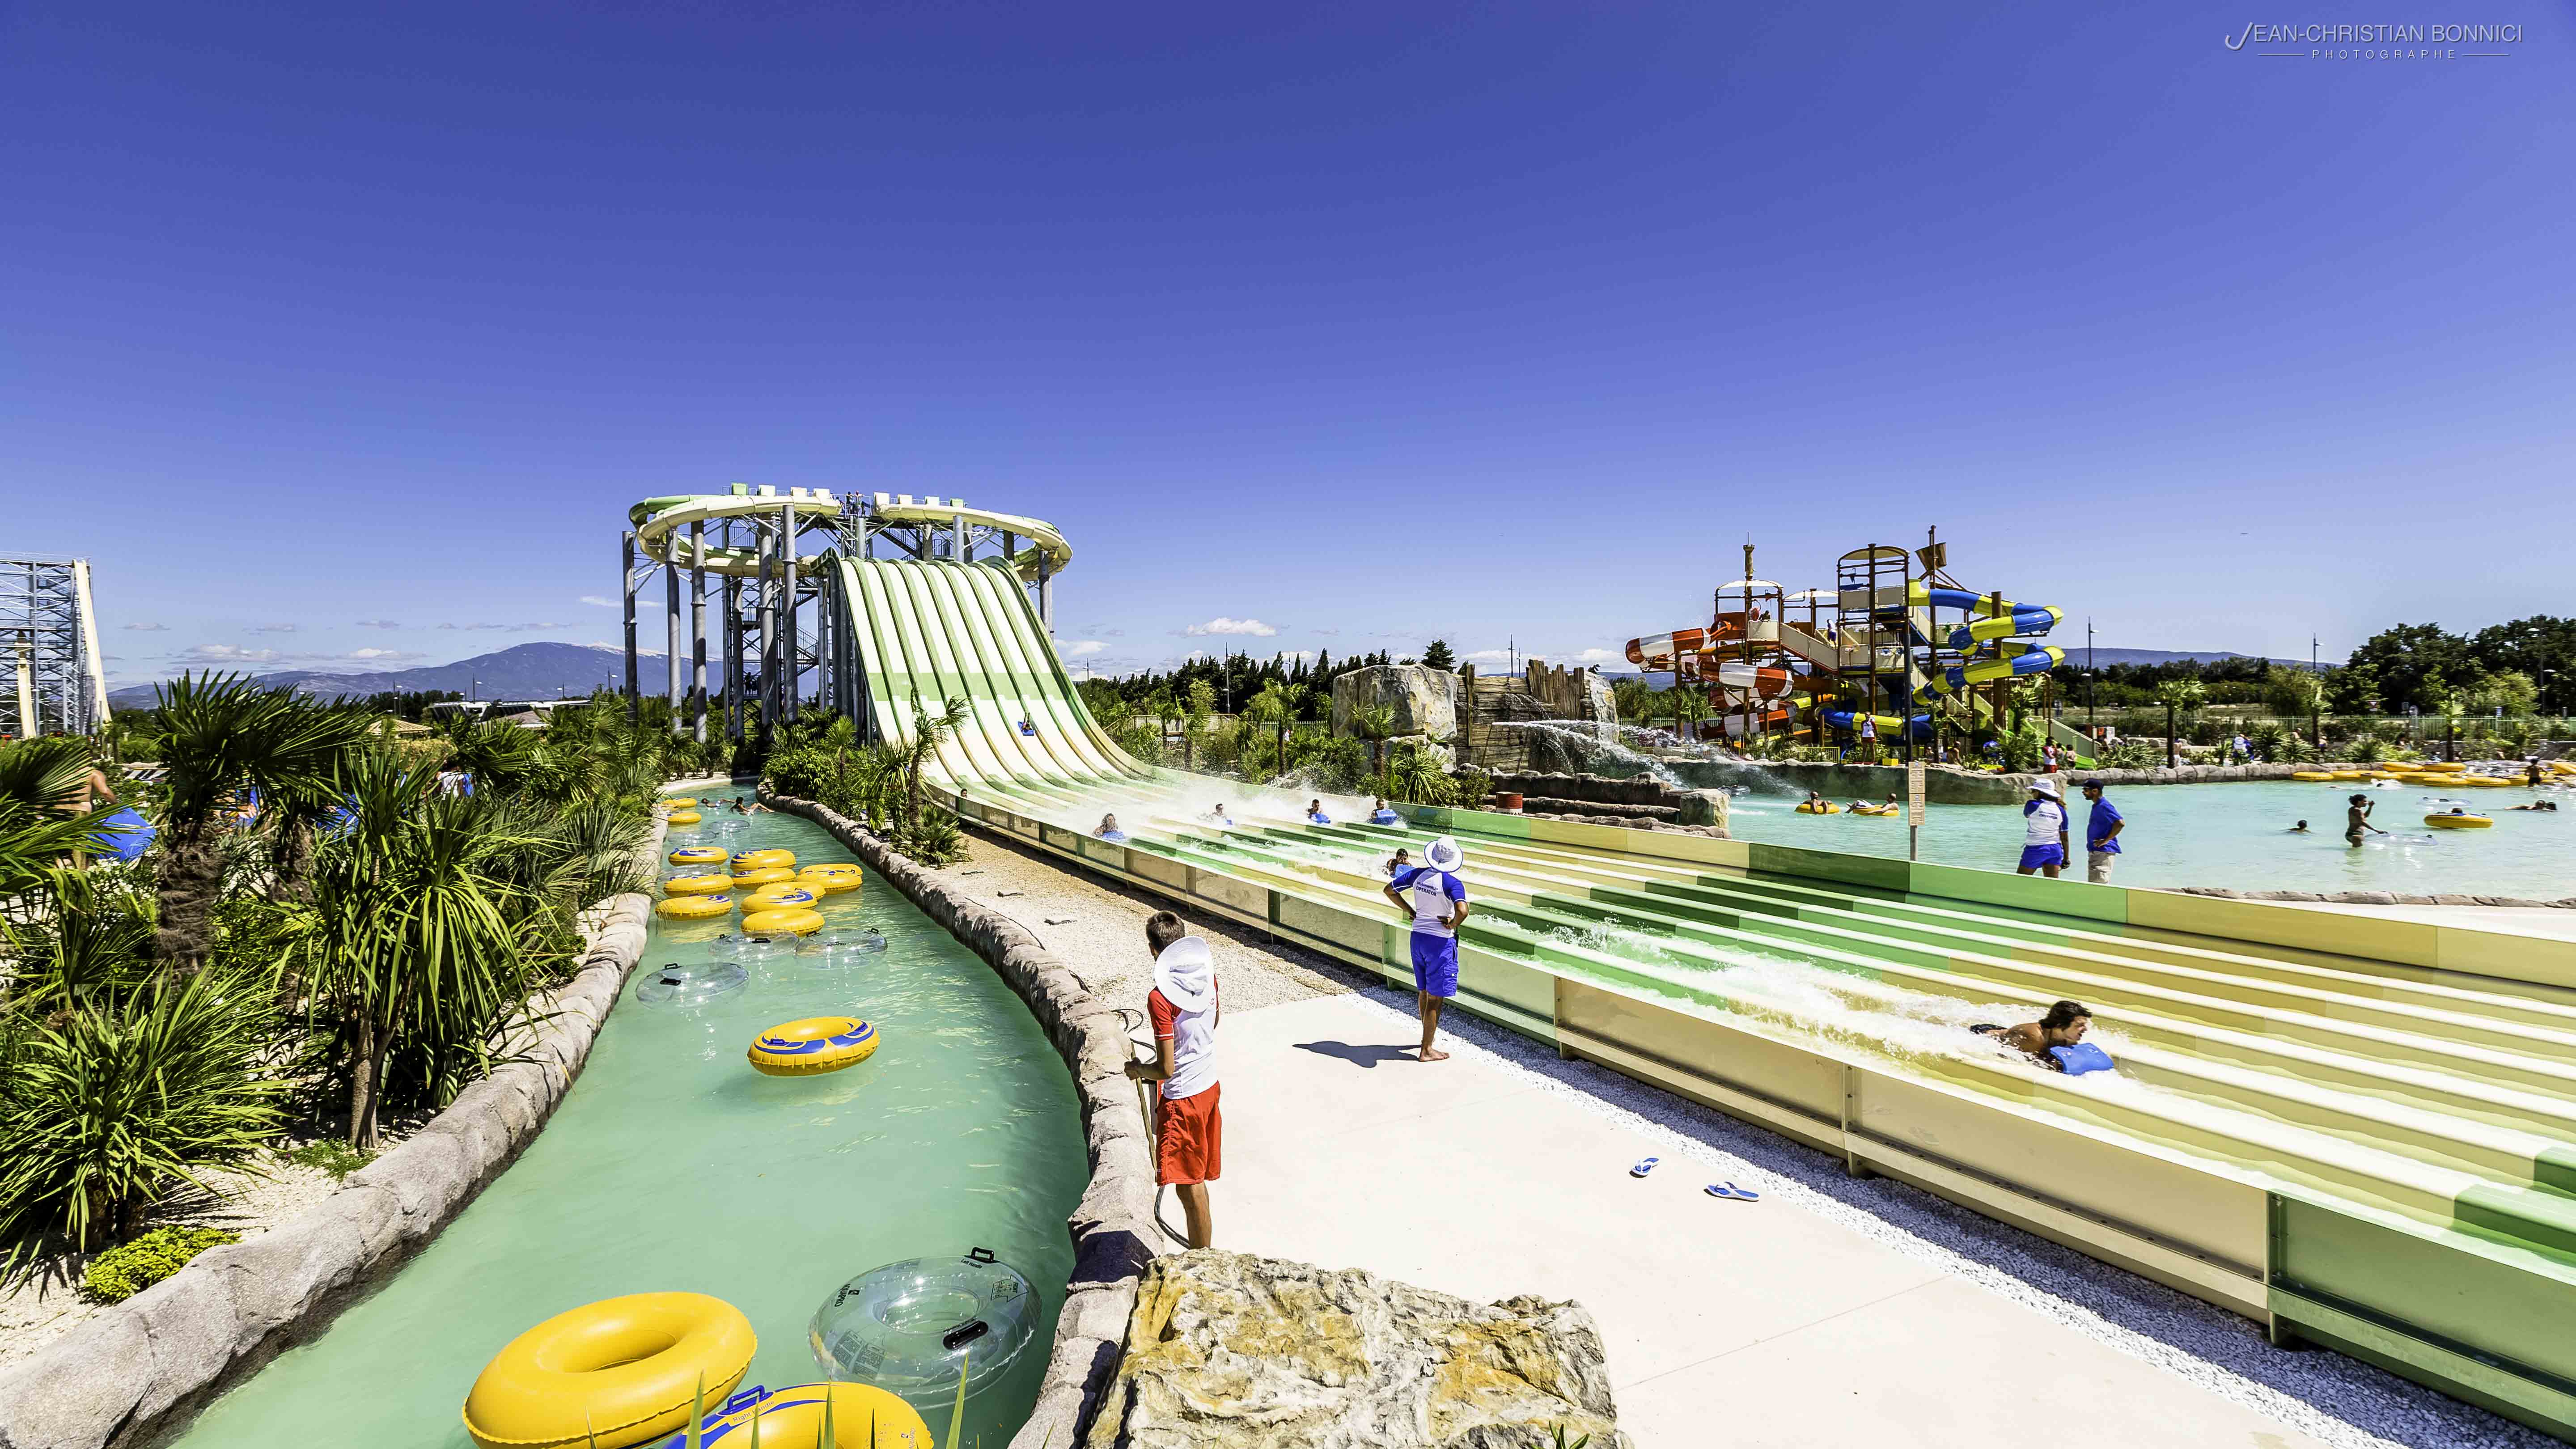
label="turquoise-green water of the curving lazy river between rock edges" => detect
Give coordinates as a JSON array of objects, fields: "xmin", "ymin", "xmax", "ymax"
[{"xmin": 161, "ymin": 794, "xmax": 1089, "ymax": 1449}]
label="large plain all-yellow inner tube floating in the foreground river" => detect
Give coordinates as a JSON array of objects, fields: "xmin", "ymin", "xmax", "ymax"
[{"xmin": 464, "ymin": 1292, "xmax": 752, "ymax": 1449}]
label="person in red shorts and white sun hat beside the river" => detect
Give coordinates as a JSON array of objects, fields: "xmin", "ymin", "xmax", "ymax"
[{"xmin": 1128, "ymin": 910, "xmax": 1226, "ymax": 1248}]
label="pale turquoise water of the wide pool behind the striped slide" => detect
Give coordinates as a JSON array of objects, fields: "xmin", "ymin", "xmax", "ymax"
[{"xmin": 1729, "ymin": 776, "xmax": 2576, "ymax": 900}]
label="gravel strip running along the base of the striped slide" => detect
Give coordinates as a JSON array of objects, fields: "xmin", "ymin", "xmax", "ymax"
[{"xmin": 940, "ymin": 833, "xmax": 2558, "ymax": 1449}]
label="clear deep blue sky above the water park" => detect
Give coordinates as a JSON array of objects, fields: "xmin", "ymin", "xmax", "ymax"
[{"xmin": 0, "ymin": 3, "xmax": 2576, "ymax": 681}]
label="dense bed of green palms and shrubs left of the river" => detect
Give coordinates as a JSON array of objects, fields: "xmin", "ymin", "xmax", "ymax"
[{"xmin": 0, "ymin": 675, "xmax": 678, "ymax": 1263}]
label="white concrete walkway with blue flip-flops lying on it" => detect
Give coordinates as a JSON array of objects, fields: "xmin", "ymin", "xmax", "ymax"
[{"xmin": 1205, "ymin": 995, "xmax": 2321, "ymax": 1449}]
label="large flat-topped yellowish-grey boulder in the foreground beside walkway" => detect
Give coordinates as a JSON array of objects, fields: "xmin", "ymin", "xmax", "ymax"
[{"xmin": 1087, "ymin": 1248, "xmax": 1631, "ymax": 1449}]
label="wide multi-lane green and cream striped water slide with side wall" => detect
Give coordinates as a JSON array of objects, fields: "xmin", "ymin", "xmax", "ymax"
[{"xmin": 830, "ymin": 528, "xmax": 2576, "ymax": 1439}]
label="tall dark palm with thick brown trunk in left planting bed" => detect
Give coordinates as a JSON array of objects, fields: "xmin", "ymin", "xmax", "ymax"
[{"xmin": 152, "ymin": 675, "xmax": 369, "ymax": 974}]
